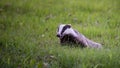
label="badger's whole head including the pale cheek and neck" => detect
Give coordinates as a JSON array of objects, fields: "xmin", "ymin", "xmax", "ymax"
[{"xmin": 57, "ymin": 24, "xmax": 76, "ymax": 38}]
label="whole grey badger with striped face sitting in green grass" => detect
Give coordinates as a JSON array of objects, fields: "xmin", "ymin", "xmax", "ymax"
[{"xmin": 57, "ymin": 24, "xmax": 102, "ymax": 48}]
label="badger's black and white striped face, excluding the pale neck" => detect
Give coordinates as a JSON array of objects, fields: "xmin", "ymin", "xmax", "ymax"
[{"xmin": 57, "ymin": 24, "xmax": 71, "ymax": 38}]
